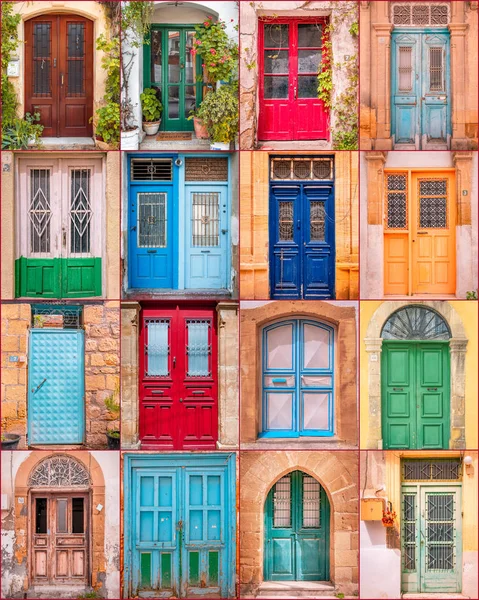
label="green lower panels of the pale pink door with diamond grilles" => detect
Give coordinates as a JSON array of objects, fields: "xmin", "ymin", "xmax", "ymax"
[{"xmin": 15, "ymin": 256, "xmax": 101, "ymax": 298}]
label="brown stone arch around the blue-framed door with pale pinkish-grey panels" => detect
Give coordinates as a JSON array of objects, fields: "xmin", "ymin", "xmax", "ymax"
[{"xmin": 240, "ymin": 300, "xmax": 357, "ymax": 445}]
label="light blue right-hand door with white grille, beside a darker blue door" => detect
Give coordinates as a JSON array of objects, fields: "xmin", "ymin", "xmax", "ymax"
[{"xmin": 185, "ymin": 184, "xmax": 230, "ymax": 289}]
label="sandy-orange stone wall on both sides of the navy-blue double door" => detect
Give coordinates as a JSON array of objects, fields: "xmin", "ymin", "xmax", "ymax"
[{"xmin": 240, "ymin": 151, "xmax": 359, "ymax": 300}]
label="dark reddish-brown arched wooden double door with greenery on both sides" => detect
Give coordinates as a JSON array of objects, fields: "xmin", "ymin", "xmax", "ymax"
[{"xmin": 25, "ymin": 15, "xmax": 93, "ymax": 137}]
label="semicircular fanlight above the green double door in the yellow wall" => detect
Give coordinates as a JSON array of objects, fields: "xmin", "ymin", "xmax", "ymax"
[{"xmin": 381, "ymin": 306, "xmax": 451, "ymax": 340}]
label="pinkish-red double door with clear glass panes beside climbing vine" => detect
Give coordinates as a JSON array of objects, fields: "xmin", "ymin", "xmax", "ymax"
[{"xmin": 258, "ymin": 18, "xmax": 329, "ymax": 140}]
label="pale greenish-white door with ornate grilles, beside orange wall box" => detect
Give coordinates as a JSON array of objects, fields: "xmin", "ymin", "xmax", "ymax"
[{"xmin": 401, "ymin": 484, "xmax": 462, "ymax": 594}]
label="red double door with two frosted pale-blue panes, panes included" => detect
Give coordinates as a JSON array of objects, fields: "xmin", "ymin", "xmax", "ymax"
[{"xmin": 140, "ymin": 305, "xmax": 218, "ymax": 450}]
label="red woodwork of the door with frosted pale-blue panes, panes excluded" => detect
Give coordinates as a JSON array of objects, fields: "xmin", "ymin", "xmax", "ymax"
[{"xmin": 139, "ymin": 303, "xmax": 218, "ymax": 450}]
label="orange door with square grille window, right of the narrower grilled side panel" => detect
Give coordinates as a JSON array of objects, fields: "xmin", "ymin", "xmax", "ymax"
[{"xmin": 411, "ymin": 173, "xmax": 456, "ymax": 294}]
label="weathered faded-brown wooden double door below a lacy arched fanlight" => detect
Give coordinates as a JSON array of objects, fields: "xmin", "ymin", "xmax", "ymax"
[{"xmin": 30, "ymin": 492, "xmax": 89, "ymax": 586}]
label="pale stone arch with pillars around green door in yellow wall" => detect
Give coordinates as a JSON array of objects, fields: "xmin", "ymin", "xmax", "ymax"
[{"xmin": 364, "ymin": 300, "xmax": 468, "ymax": 449}]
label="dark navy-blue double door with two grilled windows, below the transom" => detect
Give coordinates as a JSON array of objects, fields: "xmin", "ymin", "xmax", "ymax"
[{"xmin": 270, "ymin": 183, "xmax": 335, "ymax": 300}]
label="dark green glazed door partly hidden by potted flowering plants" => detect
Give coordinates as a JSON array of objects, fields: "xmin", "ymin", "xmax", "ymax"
[{"xmin": 143, "ymin": 25, "xmax": 203, "ymax": 131}]
